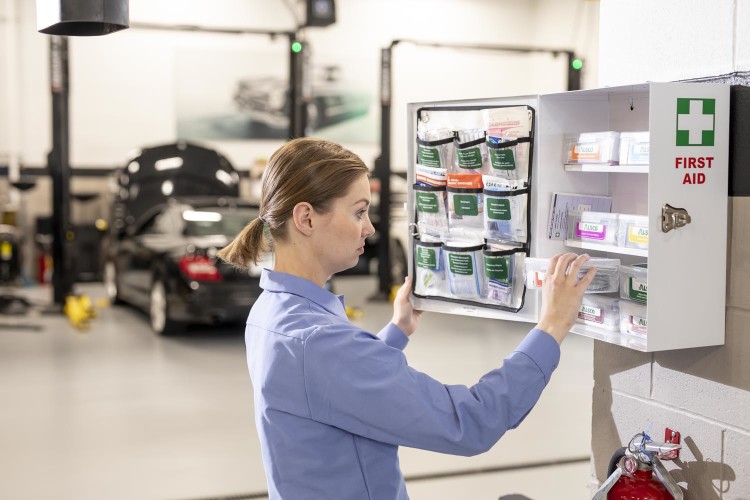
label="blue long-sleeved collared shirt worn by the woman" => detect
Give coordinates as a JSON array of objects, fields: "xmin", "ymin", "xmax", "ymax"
[{"xmin": 250, "ymin": 270, "xmax": 560, "ymax": 500}]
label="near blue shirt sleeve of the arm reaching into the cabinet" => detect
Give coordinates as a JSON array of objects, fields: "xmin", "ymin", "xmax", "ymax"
[{"xmin": 304, "ymin": 325, "xmax": 560, "ymax": 455}]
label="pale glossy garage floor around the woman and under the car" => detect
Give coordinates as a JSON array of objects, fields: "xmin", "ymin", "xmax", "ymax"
[{"xmin": 0, "ymin": 277, "xmax": 593, "ymax": 500}]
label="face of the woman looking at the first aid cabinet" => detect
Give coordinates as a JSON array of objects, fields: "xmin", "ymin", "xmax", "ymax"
[{"xmin": 315, "ymin": 174, "xmax": 375, "ymax": 275}]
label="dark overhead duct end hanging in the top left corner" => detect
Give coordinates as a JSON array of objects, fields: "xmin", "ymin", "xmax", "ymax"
[{"xmin": 36, "ymin": 0, "xmax": 129, "ymax": 36}]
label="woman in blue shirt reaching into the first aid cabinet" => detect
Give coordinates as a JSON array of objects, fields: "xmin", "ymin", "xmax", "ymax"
[{"xmin": 219, "ymin": 139, "xmax": 594, "ymax": 500}]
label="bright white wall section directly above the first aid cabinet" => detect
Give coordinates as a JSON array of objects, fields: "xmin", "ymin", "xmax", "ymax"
[{"xmin": 599, "ymin": 0, "xmax": 750, "ymax": 86}]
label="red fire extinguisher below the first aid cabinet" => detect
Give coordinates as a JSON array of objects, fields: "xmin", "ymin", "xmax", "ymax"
[{"xmin": 592, "ymin": 429, "xmax": 683, "ymax": 500}]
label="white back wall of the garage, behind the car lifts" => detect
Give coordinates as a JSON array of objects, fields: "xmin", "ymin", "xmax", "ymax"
[{"xmin": 0, "ymin": 0, "xmax": 596, "ymax": 173}]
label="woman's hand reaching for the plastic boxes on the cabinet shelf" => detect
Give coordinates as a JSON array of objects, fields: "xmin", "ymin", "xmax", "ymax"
[{"xmin": 536, "ymin": 253, "xmax": 596, "ymax": 344}]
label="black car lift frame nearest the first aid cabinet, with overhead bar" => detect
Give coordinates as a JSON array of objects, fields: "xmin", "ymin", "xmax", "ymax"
[{"xmin": 373, "ymin": 40, "xmax": 581, "ymax": 299}]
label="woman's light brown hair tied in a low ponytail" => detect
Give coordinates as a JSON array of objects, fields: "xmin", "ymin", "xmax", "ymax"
[{"xmin": 218, "ymin": 138, "xmax": 369, "ymax": 268}]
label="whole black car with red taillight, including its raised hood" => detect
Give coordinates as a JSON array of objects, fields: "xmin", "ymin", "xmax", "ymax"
[{"xmin": 104, "ymin": 142, "xmax": 260, "ymax": 334}]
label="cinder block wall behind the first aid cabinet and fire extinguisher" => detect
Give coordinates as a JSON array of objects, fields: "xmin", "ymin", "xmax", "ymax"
[{"xmin": 592, "ymin": 0, "xmax": 750, "ymax": 500}]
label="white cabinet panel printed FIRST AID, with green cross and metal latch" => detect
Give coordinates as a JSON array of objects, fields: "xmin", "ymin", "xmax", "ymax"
[{"xmin": 647, "ymin": 83, "xmax": 729, "ymax": 351}]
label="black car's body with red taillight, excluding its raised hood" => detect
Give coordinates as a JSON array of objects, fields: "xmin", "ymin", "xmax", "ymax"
[{"xmin": 104, "ymin": 196, "xmax": 268, "ymax": 334}]
